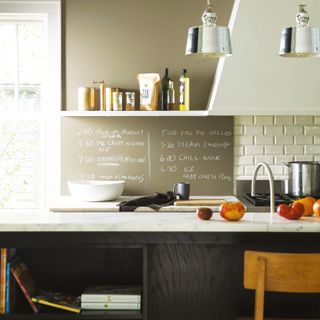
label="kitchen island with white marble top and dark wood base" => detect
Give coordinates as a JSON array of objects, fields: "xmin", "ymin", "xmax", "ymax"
[{"xmin": 0, "ymin": 212, "xmax": 320, "ymax": 320}]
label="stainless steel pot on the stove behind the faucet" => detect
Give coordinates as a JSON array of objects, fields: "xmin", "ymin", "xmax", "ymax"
[{"xmin": 282, "ymin": 161, "xmax": 320, "ymax": 198}]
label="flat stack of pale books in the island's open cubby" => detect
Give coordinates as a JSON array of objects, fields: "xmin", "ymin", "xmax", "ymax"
[{"xmin": 80, "ymin": 285, "xmax": 141, "ymax": 310}]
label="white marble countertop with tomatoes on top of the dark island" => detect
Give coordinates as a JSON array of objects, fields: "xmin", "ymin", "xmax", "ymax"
[{"xmin": 0, "ymin": 211, "xmax": 320, "ymax": 232}]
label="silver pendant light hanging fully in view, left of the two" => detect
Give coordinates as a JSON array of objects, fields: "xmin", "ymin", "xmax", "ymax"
[{"xmin": 186, "ymin": 0, "xmax": 232, "ymax": 58}]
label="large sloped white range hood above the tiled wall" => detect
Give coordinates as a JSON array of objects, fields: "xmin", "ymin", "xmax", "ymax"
[{"xmin": 208, "ymin": 0, "xmax": 320, "ymax": 115}]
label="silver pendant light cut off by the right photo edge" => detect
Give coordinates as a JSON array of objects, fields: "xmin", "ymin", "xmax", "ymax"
[{"xmin": 279, "ymin": 4, "xmax": 320, "ymax": 58}]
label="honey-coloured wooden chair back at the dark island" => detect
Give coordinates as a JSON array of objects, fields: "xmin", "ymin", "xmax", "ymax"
[{"xmin": 243, "ymin": 251, "xmax": 320, "ymax": 320}]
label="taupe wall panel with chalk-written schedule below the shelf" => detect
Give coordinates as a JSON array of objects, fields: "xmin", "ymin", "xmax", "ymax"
[{"xmin": 62, "ymin": 117, "xmax": 233, "ymax": 195}]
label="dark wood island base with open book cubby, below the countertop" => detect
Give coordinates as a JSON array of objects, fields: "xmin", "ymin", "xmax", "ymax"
[{"xmin": 0, "ymin": 232, "xmax": 320, "ymax": 320}]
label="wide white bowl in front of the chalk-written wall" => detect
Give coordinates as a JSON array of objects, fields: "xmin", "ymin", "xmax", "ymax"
[{"xmin": 68, "ymin": 180, "xmax": 124, "ymax": 201}]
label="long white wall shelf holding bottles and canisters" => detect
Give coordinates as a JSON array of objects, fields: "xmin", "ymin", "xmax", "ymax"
[{"xmin": 61, "ymin": 110, "xmax": 208, "ymax": 117}]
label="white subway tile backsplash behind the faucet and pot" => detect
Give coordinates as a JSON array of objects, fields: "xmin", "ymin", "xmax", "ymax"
[{"xmin": 234, "ymin": 116, "xmax": 320, "ymax": 179}]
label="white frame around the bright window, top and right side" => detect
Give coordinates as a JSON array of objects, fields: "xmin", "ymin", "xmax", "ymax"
[{"xmin": 0, "ymin": 0, "xmax": 61, "ymax": 215}]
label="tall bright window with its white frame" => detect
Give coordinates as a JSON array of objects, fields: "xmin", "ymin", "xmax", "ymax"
[{"xmin": 0, "ymin": 0, "xmax": 60, "ymax": 210}]
